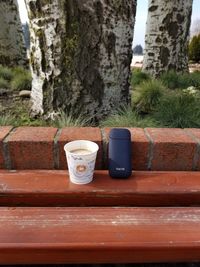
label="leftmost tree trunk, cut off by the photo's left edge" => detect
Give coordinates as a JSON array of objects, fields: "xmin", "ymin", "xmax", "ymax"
[{"xmin": 0, "ymin": 0, "xmax": 28, "ymax": 67}]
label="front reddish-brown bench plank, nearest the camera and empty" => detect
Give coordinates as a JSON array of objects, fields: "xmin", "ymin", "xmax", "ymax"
[{"xmin": 0, "ymin": 207, "xmax": 200, "ymax": 264}]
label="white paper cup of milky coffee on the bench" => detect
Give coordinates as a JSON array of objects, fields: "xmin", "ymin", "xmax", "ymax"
[{"xmin": 64, "ymin": 140, "xmax": 99, "ymax": 184}]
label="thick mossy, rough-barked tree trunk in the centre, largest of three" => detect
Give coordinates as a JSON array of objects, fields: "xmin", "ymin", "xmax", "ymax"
[{"xmin": 26, "ymin": 0, "xmax": 136, "ymax": 121}]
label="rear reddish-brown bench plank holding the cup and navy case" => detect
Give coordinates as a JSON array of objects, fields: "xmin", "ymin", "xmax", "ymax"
[{"xmin": 0, "ymin": 170, "xmax": 200, "ymax": 206}]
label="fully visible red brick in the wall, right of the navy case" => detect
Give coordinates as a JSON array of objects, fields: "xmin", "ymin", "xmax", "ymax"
[{"xmin": 146, "ymin": 128, "xmax": 197, "ymax": 171}]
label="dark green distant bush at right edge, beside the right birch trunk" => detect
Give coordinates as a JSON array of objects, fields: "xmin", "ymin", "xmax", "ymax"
[{"xmin": 189, "ymin": 34, "xmax": 200, "ymax": 63}]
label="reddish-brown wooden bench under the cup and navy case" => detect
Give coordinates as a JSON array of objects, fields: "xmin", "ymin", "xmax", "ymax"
[{"xmin": 0, "ymin": 170, "xmax": 200, "ymax": 264}]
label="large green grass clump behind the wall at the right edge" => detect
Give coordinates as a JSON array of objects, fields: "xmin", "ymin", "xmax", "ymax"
[{"xmin": 154, "ymin": 92, "xmax": 200, "ymax": 128}]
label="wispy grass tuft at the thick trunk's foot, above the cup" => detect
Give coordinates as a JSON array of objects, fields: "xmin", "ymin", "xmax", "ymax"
[{"xmin": 50, "ymin": 111, "xmax": 89, "ymax": 128}]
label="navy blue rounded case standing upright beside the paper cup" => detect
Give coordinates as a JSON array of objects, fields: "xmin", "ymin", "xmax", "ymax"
[{"xmin": 108, "ymin": 128, "xmax": 132, "ymax": 178}]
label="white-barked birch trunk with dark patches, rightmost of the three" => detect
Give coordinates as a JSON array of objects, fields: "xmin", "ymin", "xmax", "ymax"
[{"xmin": 143, "ymin": 0, "xmax": 193, "ymax": 77}]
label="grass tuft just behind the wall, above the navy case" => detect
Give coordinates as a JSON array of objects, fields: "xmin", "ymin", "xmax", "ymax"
[{"xmin": 100, "ymin": 107, "xmax": 158, "ymax": 128}]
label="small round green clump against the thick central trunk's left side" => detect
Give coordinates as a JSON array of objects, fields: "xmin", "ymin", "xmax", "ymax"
[{"xmin": 11, "ymin": 71, "xmax": 32, "ymax": 91}]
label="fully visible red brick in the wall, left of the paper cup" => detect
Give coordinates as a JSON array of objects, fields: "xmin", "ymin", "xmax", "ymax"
[{"xmin": 8, "ymin": 127, "xmax": 57, "ymax": 169}]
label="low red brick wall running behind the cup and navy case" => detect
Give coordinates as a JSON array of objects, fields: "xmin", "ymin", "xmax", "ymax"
[{"xmin": 0, "ymin": 127, "xmax": 200, "ymax": 171}]
